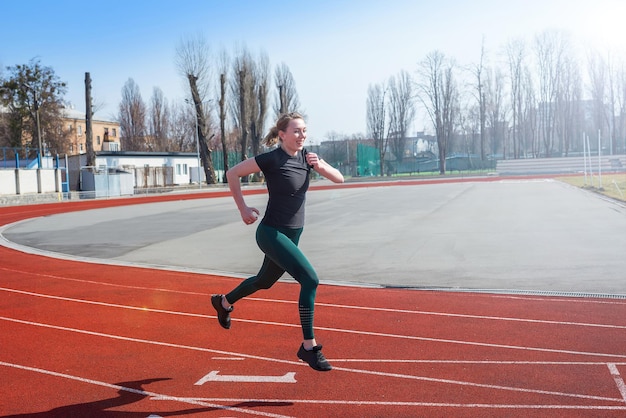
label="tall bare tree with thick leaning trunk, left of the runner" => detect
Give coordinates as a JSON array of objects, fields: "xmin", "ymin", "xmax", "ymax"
[{"xmin": 176, "ymin": 36, "xmax": 217, "ymax": 184}]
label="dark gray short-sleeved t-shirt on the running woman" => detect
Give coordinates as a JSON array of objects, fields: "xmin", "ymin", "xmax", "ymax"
[{"xmin": 254, "ymin": 147, "xmax": 311, "ymax": 228}]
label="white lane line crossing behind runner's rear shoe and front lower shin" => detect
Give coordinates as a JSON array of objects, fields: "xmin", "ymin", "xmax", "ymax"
[{"xmin": 0, "ymin": 287, "xmax": 626, "ymax": 358}]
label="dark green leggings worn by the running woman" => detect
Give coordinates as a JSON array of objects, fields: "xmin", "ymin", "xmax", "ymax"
[{"xmin": 226, "ymin": 224, "xmax": 319, "ymax": 340}]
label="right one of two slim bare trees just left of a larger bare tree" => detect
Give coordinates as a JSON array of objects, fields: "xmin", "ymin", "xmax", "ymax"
[{"xmin": 388, "ymin": 71, "xmax": 415, "ymax": 163}]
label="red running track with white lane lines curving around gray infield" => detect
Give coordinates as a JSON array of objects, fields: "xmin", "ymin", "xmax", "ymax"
[{"xmin": 0, "ymin": 188, "xmax": 626, "ymax": 418}]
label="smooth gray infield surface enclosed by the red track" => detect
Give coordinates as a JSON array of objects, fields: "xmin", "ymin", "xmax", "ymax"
[{"xmin": 2, "ymin": 179, "xmax": 626, "ymax": 297}]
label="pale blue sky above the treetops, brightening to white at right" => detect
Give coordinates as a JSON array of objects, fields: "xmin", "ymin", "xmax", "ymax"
[{"xmin": 0, "ymin": 0, "xmax": 626, "ymax": 141}]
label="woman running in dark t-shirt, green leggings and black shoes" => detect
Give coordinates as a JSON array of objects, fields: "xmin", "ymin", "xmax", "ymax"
[{"xmin": 211, "ymin": 113, "xmax": 344, "ymax": 371}]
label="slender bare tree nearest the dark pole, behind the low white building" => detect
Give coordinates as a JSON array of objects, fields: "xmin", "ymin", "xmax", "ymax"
[{"xmin": 119, "ymin": 78, "xmax": 146, "ymax": 151}]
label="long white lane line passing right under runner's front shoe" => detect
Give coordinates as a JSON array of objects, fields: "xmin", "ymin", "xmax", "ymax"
[{"xmin": 0, "ymin": 316, "xmax": 621, "ymax": 402}]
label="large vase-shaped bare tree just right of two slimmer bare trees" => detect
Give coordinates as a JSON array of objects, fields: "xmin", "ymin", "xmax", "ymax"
[{"xmin": 417, "ymin": 51, "xmax": 459, "ymax": 174}]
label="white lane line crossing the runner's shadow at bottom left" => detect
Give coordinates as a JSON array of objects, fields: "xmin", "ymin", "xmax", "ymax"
[{"xmin": 0, "ymin": 361, "xmax": 286, "ymax": 418}]
